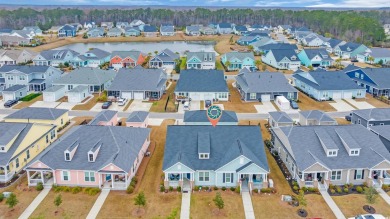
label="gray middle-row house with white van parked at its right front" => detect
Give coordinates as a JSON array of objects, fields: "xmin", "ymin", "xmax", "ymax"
[{"xmin": 236, "ymin": 71, "xmax": 298, "ymax": 102}]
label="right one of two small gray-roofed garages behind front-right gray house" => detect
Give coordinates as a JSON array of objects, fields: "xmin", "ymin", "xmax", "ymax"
[{"xmin": 299, "ymin": 110, "xmax": 337, "ymax": 125}]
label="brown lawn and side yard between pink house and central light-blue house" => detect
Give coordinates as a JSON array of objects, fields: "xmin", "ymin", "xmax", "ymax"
[{"xmin": 98, "ymin": 120, "xmax": 181, "ymax": 218}]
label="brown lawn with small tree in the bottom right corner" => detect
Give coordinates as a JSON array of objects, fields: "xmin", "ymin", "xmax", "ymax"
[{"xmin": 332, "ymin": 194, "xmax": 390, "ymax": 217}]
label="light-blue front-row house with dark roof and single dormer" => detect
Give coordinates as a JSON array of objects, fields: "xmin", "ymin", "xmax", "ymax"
[{"xmin": 163, "ymin": 125, "xmax": 270, "ymax": 192}]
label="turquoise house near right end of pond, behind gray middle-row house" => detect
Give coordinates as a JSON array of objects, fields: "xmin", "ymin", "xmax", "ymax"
[{"xmin": 221, "ymin": 52, "xmax": 256, "ymax": 71}]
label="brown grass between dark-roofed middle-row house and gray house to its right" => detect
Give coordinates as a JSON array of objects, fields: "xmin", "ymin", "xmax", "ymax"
[{"xmin": 222, "ymin": 80, "xmax": 260, "ymax": 113}]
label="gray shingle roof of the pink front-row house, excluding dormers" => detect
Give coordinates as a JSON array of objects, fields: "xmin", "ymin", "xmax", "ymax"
[{"xmin": 38, "ymin": 125, "xmax": 150, "ymax": 172}]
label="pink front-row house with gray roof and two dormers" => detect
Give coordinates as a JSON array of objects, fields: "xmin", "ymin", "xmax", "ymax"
[{"xmin": 25, "ymin": 125, "xmax": 150, "ymax": 190}]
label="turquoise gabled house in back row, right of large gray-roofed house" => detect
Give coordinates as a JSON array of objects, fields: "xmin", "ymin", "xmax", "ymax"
[{"xmin": 298, "ymin": 49, "xmax": 333, "ymax": 68}]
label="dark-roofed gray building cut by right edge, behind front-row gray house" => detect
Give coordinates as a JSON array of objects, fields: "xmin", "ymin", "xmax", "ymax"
[{"xmin": 351, "ymin": 108, "xmax": 390, "ymax": 128}]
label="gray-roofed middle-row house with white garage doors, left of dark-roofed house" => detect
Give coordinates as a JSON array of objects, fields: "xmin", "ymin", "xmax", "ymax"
[{"xmin": 108, "ymin": 66, "xmax": 167, "ymax": 100}]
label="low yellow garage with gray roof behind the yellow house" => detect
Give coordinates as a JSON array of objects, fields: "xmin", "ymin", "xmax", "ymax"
[{"xmin": 4, "ymin": 107, "xmax": 69, "ymax": 129}]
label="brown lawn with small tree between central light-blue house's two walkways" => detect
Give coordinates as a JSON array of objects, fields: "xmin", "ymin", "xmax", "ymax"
[{"xmin": 190, "ymin": 190, "xmax": 245, "ymax": 219}]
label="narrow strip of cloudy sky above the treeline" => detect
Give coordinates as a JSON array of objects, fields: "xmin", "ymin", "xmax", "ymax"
[{"xmin": 0, "ymin": 0, "xmax": 390, "ymax": 8}]
